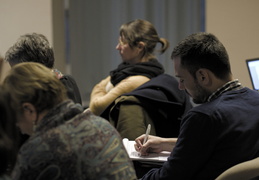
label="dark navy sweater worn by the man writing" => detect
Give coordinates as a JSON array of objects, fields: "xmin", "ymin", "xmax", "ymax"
[{"xmin": 143, "ymin": 88, "xmax": 259, "ymax": 180}]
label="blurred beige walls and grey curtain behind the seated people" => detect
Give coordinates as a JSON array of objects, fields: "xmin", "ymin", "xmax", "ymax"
[{"xmin": 0, "ymin": 0, "xmax": 259, "ymax": 106}]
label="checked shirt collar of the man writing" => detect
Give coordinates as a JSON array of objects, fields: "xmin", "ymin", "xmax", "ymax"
[{"xmin": 207, "ymin": 79, "xmax": 243, "ymax": 102}]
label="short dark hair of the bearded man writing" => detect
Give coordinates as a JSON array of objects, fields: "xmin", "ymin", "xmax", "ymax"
[{"xmin": 171, "ymin": 32, "xmax": 231, "ymax": 79}]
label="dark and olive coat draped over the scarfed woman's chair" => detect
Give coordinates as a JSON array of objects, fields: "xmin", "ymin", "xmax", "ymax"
[{"xmin": 109, "ymin": 74, "xmax": 192, "ymax": 140}]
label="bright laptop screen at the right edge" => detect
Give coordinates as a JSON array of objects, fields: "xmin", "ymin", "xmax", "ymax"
[{"xmin": 246, "ymin": 58, "xmax": 259, "ymax": 91}]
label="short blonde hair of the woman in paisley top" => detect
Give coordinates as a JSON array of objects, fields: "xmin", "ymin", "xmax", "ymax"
[{"xmin": 3, "ymin": 62, "xmax": 67, "ymax": 113}]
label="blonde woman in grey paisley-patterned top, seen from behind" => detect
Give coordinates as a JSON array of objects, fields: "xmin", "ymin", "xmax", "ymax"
[{"xmin": 3, "ymin": 62, "xmax": 136, "ymax": 180}]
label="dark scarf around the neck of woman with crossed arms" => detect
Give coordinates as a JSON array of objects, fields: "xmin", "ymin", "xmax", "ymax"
[{"xmin": 110, "ymin": 59, "xmax": 164, "ymax": 86}]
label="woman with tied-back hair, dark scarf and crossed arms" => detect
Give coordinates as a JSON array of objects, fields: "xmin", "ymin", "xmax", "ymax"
[{"xmin": 89, "ymin": 19, "xmax": 169, "ymax": 118}]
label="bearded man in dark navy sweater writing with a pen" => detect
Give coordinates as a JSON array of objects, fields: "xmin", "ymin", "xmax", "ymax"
[{"xmin": 135, "ymin": 32, "xmax": 259, "ymax": 180}]
